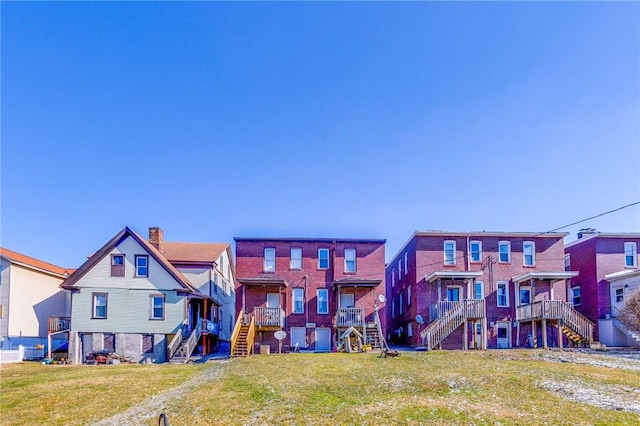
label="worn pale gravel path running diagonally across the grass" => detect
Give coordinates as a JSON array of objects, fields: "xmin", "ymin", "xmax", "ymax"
[{"xmin": 93, "ymin": 360, "xmax": 230, "ymax": 426}]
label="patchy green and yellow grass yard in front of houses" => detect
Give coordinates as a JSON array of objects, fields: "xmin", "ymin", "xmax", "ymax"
[{"xmin": 1, "ymin": 351, "xmax": 640, "ymax": 425}]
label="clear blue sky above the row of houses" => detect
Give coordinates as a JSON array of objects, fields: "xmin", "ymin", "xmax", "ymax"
[{"xmin": 0, "ymin": 2, "xmax": 640, "ymax": 267}]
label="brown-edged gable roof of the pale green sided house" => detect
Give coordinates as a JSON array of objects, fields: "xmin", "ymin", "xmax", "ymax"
[{"xmin": 60, "ymin": 226, "xmax": 200, "ymax": 297}]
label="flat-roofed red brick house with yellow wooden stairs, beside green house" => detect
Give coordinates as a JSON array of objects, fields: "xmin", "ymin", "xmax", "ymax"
[{"xmin": 232, "ymin": 238, "xmax": 386, "ymax": 355}]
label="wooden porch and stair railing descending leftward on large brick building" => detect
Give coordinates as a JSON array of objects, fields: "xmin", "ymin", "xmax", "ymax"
[{"xmin": 420, "ymin": 299, "xmax": 486, "ymax": 350}]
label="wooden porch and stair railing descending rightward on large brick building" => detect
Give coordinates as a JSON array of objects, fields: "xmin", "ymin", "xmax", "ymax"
[{"xmin": 516, "ymin": 300, "xmax": 594, "ymax": 342}]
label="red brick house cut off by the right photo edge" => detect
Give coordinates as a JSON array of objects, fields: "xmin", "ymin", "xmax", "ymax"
[{"xmin": 565, "ymin": 229, "xmax": 640, "ymax": 346}]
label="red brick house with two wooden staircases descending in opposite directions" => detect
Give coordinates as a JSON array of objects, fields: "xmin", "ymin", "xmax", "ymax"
[{"xmin": 385, "ymin": 231, "xmax": 592, "ymax": 349}]
